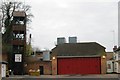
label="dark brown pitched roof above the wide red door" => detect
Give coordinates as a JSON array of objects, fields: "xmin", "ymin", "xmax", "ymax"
[{"xmin": 52, "ymin": 42, "xmax": 105, "ymax": 56}]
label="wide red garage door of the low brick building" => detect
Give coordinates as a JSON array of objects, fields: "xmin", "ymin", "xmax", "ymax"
[{"xmin": 57, "ymin": 57, "xmax": 101, "ymax": 74}]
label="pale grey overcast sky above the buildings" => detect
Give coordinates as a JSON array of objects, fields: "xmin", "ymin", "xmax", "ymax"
[{"xmin": 17, "ymin": 0, "xmax": 118, "ymax": 51}]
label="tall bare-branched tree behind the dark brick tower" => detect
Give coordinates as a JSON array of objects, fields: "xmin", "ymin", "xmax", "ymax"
[{"xmin": 0, "ymin": 1, "xmax": 33, "ymax": 52}]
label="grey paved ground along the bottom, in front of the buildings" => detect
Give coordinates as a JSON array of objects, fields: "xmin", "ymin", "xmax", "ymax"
[{"xmin": 2, "ymin": 74, "xmax": 120, "ymax": 80}]
